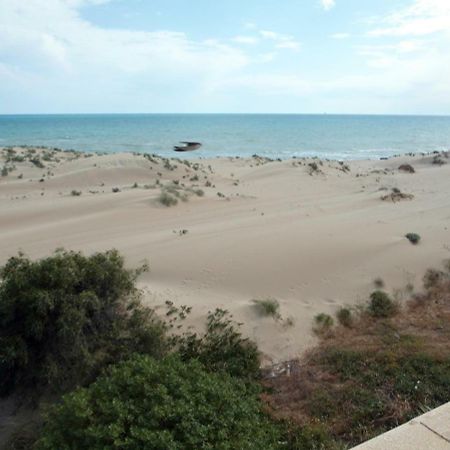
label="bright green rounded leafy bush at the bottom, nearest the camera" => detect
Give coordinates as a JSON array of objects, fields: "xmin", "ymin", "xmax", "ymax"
[{"xmin": 36, "ymin": 355, "xmax": 280, "ymax": 450}]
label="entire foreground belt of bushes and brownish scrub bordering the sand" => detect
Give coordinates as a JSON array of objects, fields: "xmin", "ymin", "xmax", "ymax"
[{"xmin": 0, "ymin": 250, "xmax": 450, "ymax": 450}]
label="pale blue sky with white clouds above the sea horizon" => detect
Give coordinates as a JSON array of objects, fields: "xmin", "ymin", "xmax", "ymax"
[{"xmin": 0, "ymin": 0, "xmax": 450, "ymax": 115}]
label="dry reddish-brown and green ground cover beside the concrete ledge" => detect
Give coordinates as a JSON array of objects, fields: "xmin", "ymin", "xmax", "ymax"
[{"xmin": 265, "ymin": 264, "xmax": 450, "ymax": 448}]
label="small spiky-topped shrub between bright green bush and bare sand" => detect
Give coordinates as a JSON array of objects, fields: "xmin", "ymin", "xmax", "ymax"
[{"xmin": 175, "ymin": 309, "xmax": 260, "ymax": 379}]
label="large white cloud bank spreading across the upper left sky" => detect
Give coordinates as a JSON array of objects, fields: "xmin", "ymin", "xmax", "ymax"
[{"xmin": 0, "ymin": 0, "xmax": 248, "ymax": 81}]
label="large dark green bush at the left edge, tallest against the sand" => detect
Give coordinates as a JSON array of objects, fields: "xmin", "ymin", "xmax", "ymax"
[{"xmin": 0, "ymin": 250, "xmax": 165, "ymax": 395}]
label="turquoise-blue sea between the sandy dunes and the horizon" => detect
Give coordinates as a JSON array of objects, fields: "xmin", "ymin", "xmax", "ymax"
[{"xmin": 0, "ymin": 114, "xmax": 450, "ymax": 159}]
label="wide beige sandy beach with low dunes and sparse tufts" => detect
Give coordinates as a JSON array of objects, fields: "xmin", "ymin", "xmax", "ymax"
[{"xmin": 0, "ymin": 147, "xmax": 450, "ymax": 363}]
